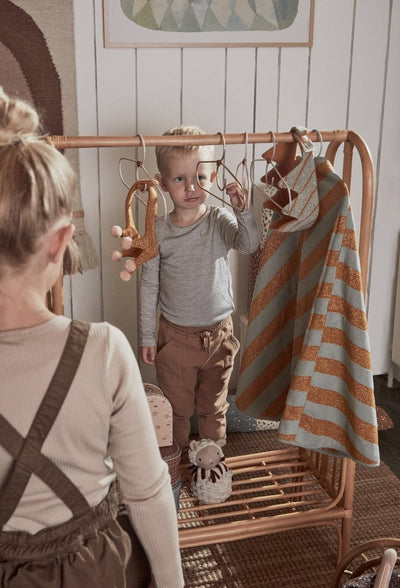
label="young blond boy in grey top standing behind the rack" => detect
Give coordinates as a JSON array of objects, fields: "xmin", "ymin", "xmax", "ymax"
[{"xmin": 139, "ymin": 126, "xmax": 259, "ymax": 456}]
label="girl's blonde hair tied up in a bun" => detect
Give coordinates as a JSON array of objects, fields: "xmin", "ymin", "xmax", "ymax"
[{"xmin": 0, "ymin": 86, "xmax": 77, "ymax": 271}]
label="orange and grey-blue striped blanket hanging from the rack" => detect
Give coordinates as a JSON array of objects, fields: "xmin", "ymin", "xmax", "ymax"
[{"xmin": 236, "ymin": 153, "xmax": 379, "ymax": 466}]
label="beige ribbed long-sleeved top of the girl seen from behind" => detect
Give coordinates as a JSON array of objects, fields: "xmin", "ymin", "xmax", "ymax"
[{"xmin": 0, "ymin": 316, "xmax": 183, "ymax": 588}]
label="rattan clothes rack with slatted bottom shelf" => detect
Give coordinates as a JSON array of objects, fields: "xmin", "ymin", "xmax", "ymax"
[{"xmin": 49, "ymin": 130, "xmax": 374, "ymax": 561}]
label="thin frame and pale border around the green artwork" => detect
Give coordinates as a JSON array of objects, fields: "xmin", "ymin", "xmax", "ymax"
[{"xmin": 103, "ymin": 0, "xmax": 315, "ymax": 48}]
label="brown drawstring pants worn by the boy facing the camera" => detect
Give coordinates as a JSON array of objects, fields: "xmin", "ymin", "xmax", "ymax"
[{"xmin": 156, "ymin": 316, "xmax": 239, "ymax": 452}]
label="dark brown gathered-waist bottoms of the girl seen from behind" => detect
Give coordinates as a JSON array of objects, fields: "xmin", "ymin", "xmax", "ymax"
[{"xmin": 0, "ymin": 489, "xmax": 131, "ymax": 588}]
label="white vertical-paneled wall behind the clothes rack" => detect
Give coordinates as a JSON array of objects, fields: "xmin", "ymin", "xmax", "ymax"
[{"xmin": 72, "ymin": 0, "xmax": 400, "ymax": 380}]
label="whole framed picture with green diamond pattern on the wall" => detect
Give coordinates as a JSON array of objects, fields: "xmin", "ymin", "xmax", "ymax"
[{"xmin": 103, "ymin": 0, "xmax": 315, "ymax": 47}]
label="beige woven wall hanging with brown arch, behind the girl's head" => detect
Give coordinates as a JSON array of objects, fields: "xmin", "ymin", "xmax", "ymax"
[{"xmin": 0, "ymin": 0, "xmax": 98, "ymax": 271}]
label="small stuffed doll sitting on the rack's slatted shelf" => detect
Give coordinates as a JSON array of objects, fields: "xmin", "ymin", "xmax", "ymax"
[{"xmin": 188, "ymin": 439, "xmax": 232, "ymax": 504}]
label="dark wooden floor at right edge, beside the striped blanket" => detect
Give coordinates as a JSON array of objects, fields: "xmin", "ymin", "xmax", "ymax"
[{"xmin": 374, "ymin": 374, "xmax": 400, "ymax": 478}]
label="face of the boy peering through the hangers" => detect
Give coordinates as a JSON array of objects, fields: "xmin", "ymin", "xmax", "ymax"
[{"xmin": 156, "ymin": 153, "xmax": 215, "ymax": 209}]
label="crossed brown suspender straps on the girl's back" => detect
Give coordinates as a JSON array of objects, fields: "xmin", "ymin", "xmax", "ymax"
[{"xmin": 0, "ymin": 320, "xmax": 90, "ymax": 529}]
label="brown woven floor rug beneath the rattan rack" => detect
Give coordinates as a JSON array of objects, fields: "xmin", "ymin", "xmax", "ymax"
[{"xmin": 182, "ymin": 431, "xmax": 400, "ymax": 588}]
